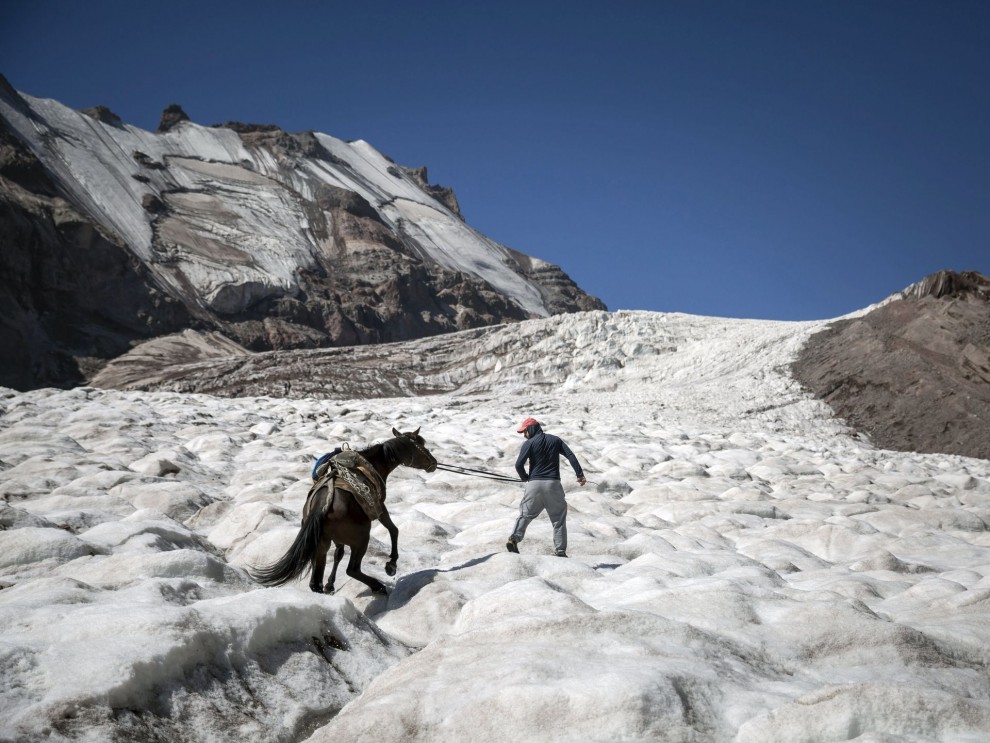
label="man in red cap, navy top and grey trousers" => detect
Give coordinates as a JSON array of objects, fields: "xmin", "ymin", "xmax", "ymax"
[{"xmin": 505, "ymin": 418, "xmax": 587, "ymax": 557}]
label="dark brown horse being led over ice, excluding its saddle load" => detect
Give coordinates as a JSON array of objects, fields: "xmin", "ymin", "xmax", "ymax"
[{"xmin": 250, "ymin": 428, "xmax": 437, "ymax": 594}]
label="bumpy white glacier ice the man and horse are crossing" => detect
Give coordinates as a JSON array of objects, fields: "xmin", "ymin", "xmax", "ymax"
[{"xmin": 0, "ymin": 313, "xmax": 990, "ymax": 742}]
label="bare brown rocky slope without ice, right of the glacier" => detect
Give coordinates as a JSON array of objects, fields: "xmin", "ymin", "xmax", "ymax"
[{"xmin": 793, "ymin": 271, "xmax": 990, "ymax": 459}]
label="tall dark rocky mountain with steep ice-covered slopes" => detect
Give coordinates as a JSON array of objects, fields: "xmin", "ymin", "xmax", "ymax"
[{"xmin": 0, "ymin": 76, "xmax": 604, "ymax": 389}]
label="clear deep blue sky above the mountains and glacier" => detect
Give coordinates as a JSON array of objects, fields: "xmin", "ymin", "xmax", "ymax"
[{"xmin": 0, "ymin": 0, "xmax": 990, "ymax": 320}]
